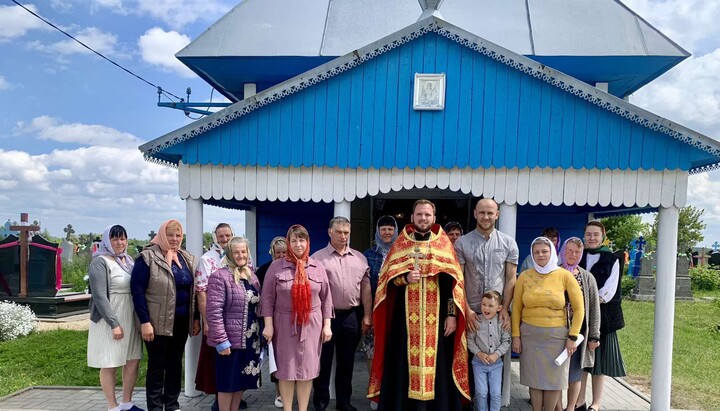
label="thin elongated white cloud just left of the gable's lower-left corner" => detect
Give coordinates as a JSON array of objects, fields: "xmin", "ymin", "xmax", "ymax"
[{"xmin": 17, "ymin": 116, "xmax": 142, "ymax": 148}]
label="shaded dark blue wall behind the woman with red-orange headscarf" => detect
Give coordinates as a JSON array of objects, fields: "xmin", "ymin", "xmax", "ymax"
[{"xmin": 253, "ymin": 201, "xmax": 333, "ymax": 266}]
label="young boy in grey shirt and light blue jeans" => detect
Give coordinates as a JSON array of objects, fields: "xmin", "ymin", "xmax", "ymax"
[{"xmin": 468, "ymin": 291, "xmax": 510, "ymax": 411}]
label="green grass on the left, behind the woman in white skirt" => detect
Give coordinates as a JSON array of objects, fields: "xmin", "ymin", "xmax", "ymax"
[{"xmin": 0, "ymin": 330, "xmax": 146, "ymax": 397}]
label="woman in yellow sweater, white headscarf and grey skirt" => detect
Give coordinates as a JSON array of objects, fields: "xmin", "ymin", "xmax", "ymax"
[{"xmin": 512, "ymin": 237, "xmax": 585, "ymax": 411}]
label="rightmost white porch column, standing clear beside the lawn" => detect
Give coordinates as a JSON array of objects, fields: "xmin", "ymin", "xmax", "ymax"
[{"xmin": 650, "ymin": 206, "xmax": 679, "ymax": 410}]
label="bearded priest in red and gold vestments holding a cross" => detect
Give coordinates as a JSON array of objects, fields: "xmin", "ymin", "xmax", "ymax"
[{"xmin": 368, "ymin": 200, "xmax": 470, "ymax": 411}]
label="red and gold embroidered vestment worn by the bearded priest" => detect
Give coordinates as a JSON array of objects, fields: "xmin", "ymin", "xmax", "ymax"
[{"xmin": 368, "ymin": 224, "xmax": 470, "ymax": 401}]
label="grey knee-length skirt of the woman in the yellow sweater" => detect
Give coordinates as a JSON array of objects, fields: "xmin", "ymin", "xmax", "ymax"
[{"xmin": 520, "ymin": 323, "xmax": 570, "ymax": 390}]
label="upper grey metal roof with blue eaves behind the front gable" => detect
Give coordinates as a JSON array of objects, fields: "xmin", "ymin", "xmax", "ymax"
[{"xmin": 176, "ymin": 0, "xmax": 689, "ymax": 101}]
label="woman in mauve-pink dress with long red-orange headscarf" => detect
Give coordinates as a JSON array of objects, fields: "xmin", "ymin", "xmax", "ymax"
[{"xmin": 260, "ymin": 225, "xmax": 333, "ymax": 411}]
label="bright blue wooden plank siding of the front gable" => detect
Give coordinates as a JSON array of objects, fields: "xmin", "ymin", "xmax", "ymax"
[{"xmin": 177, "ymin": 33, "xmax": 709, "ymax": 170}]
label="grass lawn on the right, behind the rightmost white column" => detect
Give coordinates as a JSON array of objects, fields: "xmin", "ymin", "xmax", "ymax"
[{"xmin": 618, "ymin": 300, "xmax": 720, "ymax": 410}]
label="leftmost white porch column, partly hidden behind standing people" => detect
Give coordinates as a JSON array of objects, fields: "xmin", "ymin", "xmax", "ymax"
[{"xmin": 185, "ymin": 198, "xmax": 203, "ymax": 397}]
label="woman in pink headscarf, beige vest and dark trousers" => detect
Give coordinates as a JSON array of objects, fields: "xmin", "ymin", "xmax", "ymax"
[{"xmin": 130, "ymin": 220, "xmax": 200, "ymax": 411}]
